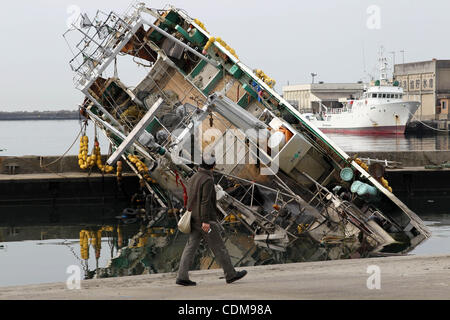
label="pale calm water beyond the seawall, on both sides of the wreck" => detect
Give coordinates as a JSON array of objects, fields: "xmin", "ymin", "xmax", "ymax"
[{"xmin": 0, "ymin": 120, "xmax": 450, "ymax": 156}]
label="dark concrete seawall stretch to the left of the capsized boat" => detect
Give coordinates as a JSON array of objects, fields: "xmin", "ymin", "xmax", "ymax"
[{"xmin": 0, "ymin": 156, "xmax": 139, "ymax": 226}]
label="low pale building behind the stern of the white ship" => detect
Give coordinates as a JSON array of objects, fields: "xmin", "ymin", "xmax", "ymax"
[{"xmin": 283, "ymin": 82, "xmax": 364, "ymax": 112}]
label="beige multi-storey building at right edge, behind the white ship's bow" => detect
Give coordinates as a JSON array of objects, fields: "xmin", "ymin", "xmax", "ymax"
[{"xmin": 394, "ymin": 59, "xmax": 450, "ymax": 120}]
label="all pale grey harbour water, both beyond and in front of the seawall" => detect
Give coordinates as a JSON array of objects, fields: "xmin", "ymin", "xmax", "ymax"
[{"xmin": 0, "ymin": 120, "xmax": 450, "ymax": 286}]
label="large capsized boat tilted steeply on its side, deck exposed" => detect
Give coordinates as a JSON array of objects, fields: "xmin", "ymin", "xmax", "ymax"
[{"xmin": 64, "ymin": 4, "xmax": 430, "ymax": 272}]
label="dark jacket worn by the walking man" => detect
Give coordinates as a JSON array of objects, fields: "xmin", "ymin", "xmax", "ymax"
[{"xmin": 187, "ymin": 168, "xmax": 217, "ymax": 229}]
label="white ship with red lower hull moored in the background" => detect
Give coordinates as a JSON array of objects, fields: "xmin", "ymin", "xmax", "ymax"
[{"xmin": 305, "ymin": 53, "xmax": 420, "ymax": 134}]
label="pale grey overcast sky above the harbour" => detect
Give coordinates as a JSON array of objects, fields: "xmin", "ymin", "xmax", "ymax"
[{"xmin": 0, "ymin": 0, "xmax": 450, "ymax": 111}]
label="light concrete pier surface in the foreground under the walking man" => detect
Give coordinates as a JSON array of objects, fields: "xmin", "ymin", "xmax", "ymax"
[{"xmin": 0, "ymin": 255, "xmax": 450, "ymax": 300}]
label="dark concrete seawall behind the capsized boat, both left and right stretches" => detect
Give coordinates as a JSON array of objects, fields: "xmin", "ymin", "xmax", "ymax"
[{"xmin": 0, "ymin": 151, "xmax": 450, "ymax": 222}]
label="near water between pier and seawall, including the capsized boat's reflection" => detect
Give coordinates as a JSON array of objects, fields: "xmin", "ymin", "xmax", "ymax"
[{"xmin": 0, "ymin": 214, "xmax": 450, "ymax": 286}]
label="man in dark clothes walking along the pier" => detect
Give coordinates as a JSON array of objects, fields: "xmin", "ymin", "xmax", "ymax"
[{"xmin": 176, "ymin": 157, "xmax": 247, "ymax": 286}]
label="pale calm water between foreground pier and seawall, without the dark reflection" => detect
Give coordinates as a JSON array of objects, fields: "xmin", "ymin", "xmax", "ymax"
[{"xmin": 0, "ymin": 214, "xmax": 450, "ymax": 287}]
